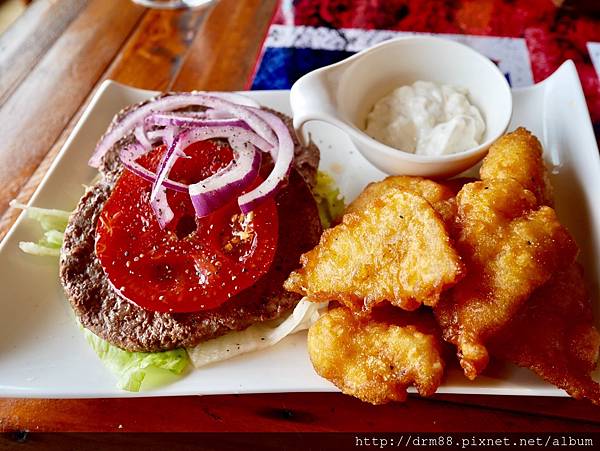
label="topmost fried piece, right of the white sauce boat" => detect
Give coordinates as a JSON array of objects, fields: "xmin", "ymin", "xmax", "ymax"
[{"xmin": 479, "ymin": 127, "xmax": 553, "ymax": 206}]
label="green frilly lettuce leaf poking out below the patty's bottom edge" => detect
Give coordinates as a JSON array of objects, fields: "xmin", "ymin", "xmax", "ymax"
[{"xmin": 83, "ymin": 329, "xmax": 189, "ymax": 392}]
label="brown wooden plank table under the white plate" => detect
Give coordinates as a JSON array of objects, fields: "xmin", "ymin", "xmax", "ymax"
[{"xmin": 0, "ymin": 0, "xmax": 600, "ymax": 438}]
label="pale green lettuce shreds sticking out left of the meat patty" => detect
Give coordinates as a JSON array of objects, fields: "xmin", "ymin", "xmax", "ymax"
[{"xmin": 10, "ymin": 200, "xmax": 71, "ymax": 257}]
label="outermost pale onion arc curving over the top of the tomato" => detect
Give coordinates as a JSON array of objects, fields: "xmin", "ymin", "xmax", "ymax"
[{"xmin": 89, "ymin": 93, "xmax": 277, "ymax": 168}]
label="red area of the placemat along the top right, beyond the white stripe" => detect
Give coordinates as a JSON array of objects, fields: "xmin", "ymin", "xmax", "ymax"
[{"xmin": 275, "ymin": 0, "xmax": 600, "ymax": 124}]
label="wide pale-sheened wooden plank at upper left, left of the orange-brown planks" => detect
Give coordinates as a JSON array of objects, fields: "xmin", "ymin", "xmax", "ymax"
[{"xmin": 0, "ymin": 0, "xmax": 144, "ymax": 222}]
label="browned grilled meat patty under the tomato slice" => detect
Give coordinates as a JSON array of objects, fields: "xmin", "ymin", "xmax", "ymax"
[{"xmin": 60, "ymin": 94, "xmax": 322, "ymax": 352}]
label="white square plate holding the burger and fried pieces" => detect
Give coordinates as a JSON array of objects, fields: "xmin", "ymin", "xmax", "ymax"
[{"xmin": 0, "ymin": 62, "xmax": 600, "ymax": 398}]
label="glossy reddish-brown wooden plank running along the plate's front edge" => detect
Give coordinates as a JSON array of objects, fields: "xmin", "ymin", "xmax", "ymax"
[{"xmin": 0, "ymin": 393, "xmax": 600, "ymax": 432}]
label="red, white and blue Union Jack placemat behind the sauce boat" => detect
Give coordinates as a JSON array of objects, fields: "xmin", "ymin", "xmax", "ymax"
[{"xmin": 251, "ymin": 0, "xmax": 600, "ymax": 141}]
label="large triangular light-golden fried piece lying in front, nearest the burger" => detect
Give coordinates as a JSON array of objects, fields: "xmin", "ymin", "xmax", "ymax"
[{"xmin": 284, "ymin": 190, "xmax": 463, "ymax": 311}]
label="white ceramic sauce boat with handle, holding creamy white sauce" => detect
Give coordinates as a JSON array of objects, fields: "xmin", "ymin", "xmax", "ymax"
[{"xmin": 290, "ymin": 36, "xmax": 512, "ymax": 177}]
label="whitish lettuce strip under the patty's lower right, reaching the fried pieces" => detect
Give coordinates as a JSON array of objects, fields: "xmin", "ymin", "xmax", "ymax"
[{"xmin": 187, "ymin": 298, "xmax": 327, "ymax": 368}]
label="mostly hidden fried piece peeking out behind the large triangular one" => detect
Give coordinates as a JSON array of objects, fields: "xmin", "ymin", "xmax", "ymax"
[{"xmin": 346, "ymin": 175, "xmax": 458, "ymax": 223}]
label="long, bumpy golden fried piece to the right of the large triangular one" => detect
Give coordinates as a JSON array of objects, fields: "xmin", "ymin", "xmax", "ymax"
[{"xmin": 434, "ymin": 179, "xmax": 577, "ymax": 379}]
